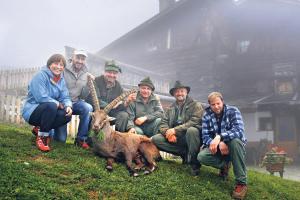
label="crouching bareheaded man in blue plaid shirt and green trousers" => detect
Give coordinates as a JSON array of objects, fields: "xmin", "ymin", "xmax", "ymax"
[{"xmin": 197, "ymin": 92, "xmax": 247, "ymax": 199}]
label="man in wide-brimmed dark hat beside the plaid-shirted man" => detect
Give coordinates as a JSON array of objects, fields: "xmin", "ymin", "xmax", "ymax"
[{"xmin": 152, "ymin": 81, "xmax": 203, "ymax": 176}]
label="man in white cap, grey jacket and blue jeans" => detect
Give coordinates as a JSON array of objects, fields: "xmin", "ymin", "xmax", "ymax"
[{"xmin": 55, "ymin": 50, "xmax": 93, "ymax": 149}]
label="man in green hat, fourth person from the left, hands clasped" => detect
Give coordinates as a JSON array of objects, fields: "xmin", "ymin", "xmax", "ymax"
[{"xmin": 127, "ymin": 77, "xmax": 163, "ymax": 137}]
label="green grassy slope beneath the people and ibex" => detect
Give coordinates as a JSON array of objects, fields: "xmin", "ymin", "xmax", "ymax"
[{"xmin": 0, "ymin": 124, "xmax": 300, "ymax": 200}]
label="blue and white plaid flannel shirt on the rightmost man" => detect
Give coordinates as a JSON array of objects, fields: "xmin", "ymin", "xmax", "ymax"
[{"xmin": 202, "ymin": 104, "xmax": 247, "ymax": 147}]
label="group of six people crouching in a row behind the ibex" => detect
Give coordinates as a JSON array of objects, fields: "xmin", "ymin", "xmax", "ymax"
[{"xmin": 22, "ymin": 50, "xmax": 247, "ymax": 198}]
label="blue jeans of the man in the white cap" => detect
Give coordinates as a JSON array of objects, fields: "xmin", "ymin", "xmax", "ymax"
[{"xmin": 53, "ymin": 100, "xmax": 93, "ymax": 142}]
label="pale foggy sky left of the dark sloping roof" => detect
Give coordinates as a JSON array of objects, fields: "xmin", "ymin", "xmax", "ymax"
[{"xmin": 0, "ymin": 0, "xmax": 159, "ymax": 68}]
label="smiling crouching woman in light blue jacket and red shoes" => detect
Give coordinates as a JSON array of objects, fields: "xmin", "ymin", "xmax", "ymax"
[{"xmin": 22, "ymin": 54, "xmax": 72, "ymax": 151}]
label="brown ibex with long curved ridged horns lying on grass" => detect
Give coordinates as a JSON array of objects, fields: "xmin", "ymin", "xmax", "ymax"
[{"xmin": 88, "ymin": 74, "xmax": 160, "ymax": 176}]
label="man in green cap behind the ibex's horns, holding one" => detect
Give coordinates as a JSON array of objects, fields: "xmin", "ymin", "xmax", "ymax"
[{"xmin": 86, "ymin": 60, "xmax": 136, "ymax": 132}]
